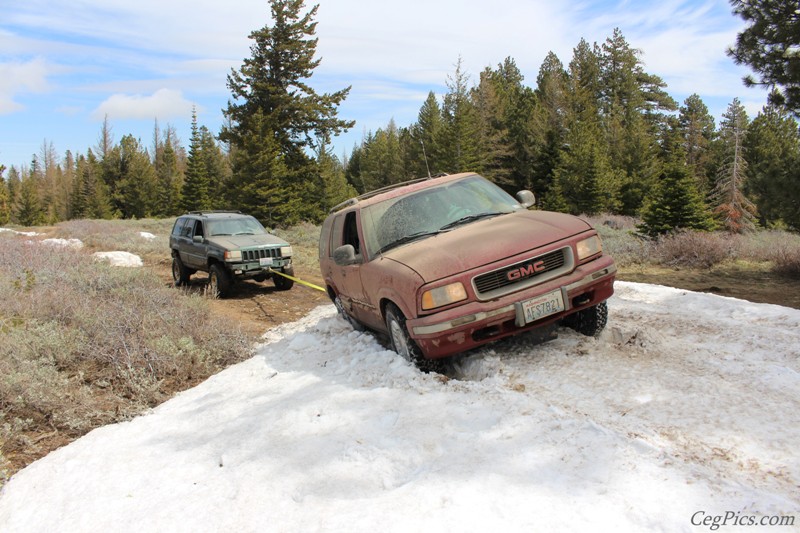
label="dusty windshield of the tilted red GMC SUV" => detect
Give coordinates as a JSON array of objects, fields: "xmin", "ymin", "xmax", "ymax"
[{"xmin": 362, "ymin": 176, "xmax": 524, "ymax": 256}]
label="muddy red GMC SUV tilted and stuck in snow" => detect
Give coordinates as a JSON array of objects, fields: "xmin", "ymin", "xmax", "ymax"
[{"xmin": 319, "ymin": 173, "xmax": 616, "ymax": 370}]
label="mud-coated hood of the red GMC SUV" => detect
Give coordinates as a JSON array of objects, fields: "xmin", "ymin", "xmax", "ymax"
[{"xmin": 383, "ymin": 211, "xmax": 591, "ymax": 283}]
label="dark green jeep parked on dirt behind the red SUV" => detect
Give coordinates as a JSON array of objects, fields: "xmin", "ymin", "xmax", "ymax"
[{"xmin": 169, "ymin": 211, "xmax": 294, "ymax": 297}]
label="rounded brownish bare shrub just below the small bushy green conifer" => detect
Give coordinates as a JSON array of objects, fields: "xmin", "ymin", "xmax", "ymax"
[{"xmin": 654, "ymin": 231, "xmax": 739, "ymax": 268}]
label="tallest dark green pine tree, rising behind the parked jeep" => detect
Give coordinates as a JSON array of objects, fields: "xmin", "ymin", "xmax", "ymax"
[{"xmin": 220, "ymin": 0, "xmax": 354, "ymax": 223}]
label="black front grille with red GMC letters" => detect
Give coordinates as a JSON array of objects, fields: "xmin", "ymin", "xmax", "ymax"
[{"xmin": 472, "ymin": 248, "xmax": 573, "ymax": 299}]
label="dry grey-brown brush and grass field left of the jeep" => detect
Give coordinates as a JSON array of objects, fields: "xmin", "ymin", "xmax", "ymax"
[{"xmin": 0, "ymin": 229, "xmax": 252, "ymax": 481}]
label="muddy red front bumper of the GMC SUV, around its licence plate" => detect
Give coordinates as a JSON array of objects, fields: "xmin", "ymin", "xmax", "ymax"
[{"xmin": 406, "ymin": 256, "xmax": 617, "ymax": 358}]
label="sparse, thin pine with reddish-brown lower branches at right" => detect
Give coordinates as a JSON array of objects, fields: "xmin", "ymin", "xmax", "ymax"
[{"xmin": 712, "ymin": 98, "xmax": 756, "ymax": 233}]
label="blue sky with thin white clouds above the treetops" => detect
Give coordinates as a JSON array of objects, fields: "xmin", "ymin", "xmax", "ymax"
[{"xmin": 0, "ymin": 0, "xmax": 766, "ymax": 172}]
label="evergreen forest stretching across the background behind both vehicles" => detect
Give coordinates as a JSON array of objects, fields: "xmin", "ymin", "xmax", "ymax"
[{"xmin": 0, "ymin": 0, "xmax": 800, "ymax": 235}]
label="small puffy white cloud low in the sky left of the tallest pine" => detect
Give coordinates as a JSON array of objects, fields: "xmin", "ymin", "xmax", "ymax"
[{"xmin": 92, "ymin": 89, "xmax": 193, "ymax": 120}]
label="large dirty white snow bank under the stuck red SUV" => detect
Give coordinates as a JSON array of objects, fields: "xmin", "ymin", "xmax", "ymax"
[{"xmin": 0, "ymin": 282, "xmax": 800, "ymax": 532}]
